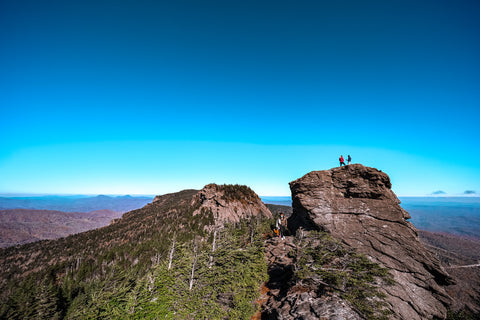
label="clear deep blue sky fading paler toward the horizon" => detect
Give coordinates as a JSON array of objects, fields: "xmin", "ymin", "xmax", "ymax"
[{"xmin": 0, "ymin": 0, "xmax": 480, "ymax": 196}]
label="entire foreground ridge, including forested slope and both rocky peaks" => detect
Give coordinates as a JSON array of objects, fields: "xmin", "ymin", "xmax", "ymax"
[{"xmin": 0, "ymin": 171, "xmax": 480, "ymax": 320}]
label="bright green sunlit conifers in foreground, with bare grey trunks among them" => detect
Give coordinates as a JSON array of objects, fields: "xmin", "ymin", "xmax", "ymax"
[{"xmin": 62, "ymin": 219, "xmax": 267, "ymax": 319}]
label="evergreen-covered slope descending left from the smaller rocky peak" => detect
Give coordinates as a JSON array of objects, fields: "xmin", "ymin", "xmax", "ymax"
[{"xmin": 0, "ymin": 187, "xmax": 269, "ymax": 319}]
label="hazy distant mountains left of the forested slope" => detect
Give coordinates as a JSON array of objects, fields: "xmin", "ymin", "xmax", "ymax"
[{"xmin": 0, "ymin": 195, "xmax": 153, "ymax": 248}]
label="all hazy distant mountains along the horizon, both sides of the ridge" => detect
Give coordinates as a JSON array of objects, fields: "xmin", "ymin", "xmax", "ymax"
[{"xmin": 0, "ymin": 195, "xmax": 480, "ymax": 247}]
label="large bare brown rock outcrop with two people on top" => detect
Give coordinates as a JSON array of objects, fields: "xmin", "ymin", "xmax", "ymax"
[{"xmin": 289, "ymin": 164, "xmax": 452, "ymax": 320}]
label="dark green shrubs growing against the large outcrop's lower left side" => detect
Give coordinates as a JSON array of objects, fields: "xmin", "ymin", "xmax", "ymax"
[{"xmin": 295, "ymin": 231, "xmax": 394, "ymax": 320}]
